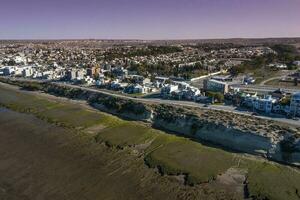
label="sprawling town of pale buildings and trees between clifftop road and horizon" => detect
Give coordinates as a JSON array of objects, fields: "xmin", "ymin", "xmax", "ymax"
[{"xmin": 0, "ymin": 40, "xmax": 300, "ymax": 120}]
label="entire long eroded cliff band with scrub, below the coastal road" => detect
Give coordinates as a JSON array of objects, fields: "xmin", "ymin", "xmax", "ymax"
[{"xmin": 0, "ymin": 78, "xmax": 300, "ymax": 166}]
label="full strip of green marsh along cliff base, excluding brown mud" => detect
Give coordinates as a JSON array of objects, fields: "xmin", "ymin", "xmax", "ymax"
[{"xmin": 0, "ymin": 86, "xmax": 300, "ymax": 199}]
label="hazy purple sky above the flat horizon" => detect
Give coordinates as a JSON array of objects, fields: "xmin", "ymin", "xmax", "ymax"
[{"xmin": 0, "ymin": 0, "xmax": 300, "ymax": 40}]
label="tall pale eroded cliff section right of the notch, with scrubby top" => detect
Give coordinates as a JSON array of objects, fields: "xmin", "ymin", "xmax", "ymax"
[{"xmin": 152, "ymin": 105, "xmax": 300, "ymax": 166}]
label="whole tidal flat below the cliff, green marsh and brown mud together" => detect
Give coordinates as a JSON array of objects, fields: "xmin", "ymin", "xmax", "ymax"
[{"xmin": 0, "ymin": 84, "xmax": 300, "ymax": 200}]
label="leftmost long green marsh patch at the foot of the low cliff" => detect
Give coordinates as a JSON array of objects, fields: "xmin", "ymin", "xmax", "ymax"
[{"xmin": 0, "ymin": 85, "xmax": 123, "ymax": 129}]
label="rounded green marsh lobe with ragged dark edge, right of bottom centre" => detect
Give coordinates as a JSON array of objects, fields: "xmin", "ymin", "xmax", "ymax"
[{"xmin": 145, "ymin": 137, "xmax": 235, "ymax": 185}]
